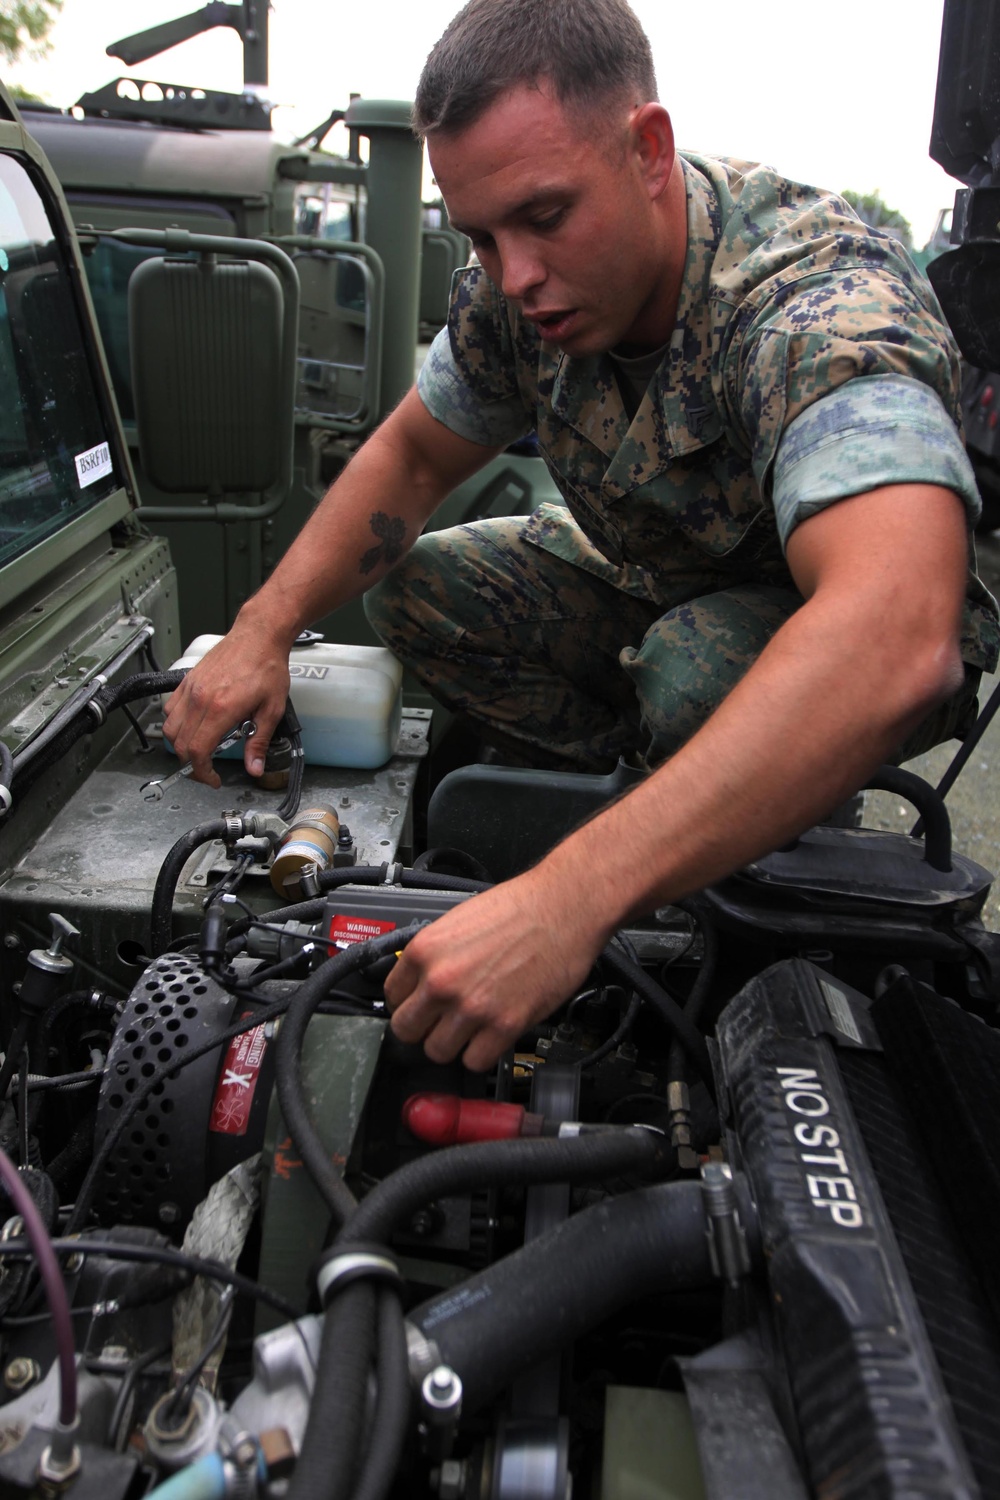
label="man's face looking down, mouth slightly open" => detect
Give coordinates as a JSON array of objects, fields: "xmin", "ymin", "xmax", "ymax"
[{"xmin": 429, "ymin": 81, "xmax": 680, "ymax": 356}]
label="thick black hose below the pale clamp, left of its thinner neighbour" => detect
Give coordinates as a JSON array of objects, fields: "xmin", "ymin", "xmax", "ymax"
[{"xmin": 288, "ymin": 1281, "xmax": 379, "ymax": 1500}]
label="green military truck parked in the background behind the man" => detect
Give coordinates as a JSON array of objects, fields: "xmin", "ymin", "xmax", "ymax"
[{"xmin": 17, "ymin": 0, "xmax": 555, "ymax": 642}]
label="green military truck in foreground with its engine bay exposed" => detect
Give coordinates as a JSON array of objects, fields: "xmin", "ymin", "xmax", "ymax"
[{"xmin": 0, "ymin": 5, "xmax": 1000, "ymax": 1500}]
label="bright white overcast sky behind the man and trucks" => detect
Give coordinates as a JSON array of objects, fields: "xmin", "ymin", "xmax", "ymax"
[{"xmin": 4, "ymin": 0, "xmax": 958, "ymax": 246}]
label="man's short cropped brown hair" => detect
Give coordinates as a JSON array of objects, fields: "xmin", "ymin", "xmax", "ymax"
[{"xmin": 414, "ymin": 0, "xmax": 658, "ymax": 137}]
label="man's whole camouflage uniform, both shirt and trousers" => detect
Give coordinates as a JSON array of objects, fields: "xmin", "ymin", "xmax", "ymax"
[{"xmin": 367, "ymin": 155, "xmax": 1000, "ymax": 770}]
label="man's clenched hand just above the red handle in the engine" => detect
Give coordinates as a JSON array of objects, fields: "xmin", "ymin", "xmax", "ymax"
[{"xmin": 385, "ymin": 866, "xmax": 606, "ymax": 1071}]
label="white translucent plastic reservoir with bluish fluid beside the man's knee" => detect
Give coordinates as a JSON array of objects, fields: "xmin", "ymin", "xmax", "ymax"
[{"xmin": 172, "ymin": 636, "xmax": 403, "ymax": 770}]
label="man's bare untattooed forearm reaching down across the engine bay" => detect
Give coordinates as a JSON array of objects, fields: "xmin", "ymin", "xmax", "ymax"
[{"xmin": 546, "ymin": 576, "xmax": 961, "ymax": 936}]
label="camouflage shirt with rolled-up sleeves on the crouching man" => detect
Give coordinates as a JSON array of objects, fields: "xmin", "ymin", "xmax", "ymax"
[{"xmin": 418, "ymin": 153, "xmax": 1000, "ymax": 671}]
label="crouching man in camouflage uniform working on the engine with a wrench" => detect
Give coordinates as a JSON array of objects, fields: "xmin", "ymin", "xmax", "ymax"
[{"xmin": 165, "ymin": 0, "xmax": 997, "ymax": 1068}]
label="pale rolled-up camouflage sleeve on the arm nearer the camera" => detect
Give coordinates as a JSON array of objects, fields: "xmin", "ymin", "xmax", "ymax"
[{"xmin": 772, "ymin": 375, "xmax": 982, "ymax": 546}]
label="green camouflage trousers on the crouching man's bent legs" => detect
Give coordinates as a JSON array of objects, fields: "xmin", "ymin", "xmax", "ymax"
[{"xmin": 366, "ymin": 518, "xmax": 979, "ymax": 771}]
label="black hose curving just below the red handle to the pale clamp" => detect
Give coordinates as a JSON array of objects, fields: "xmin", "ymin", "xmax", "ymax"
[{"xmin": 338, "ymin": 1128, "xmax": 669, "ymax": 1245}]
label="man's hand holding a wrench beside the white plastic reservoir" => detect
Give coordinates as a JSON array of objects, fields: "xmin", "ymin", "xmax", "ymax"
[{"xmin": 163, "ymin": 620, "xmax": 289, "ymax": 786}]
